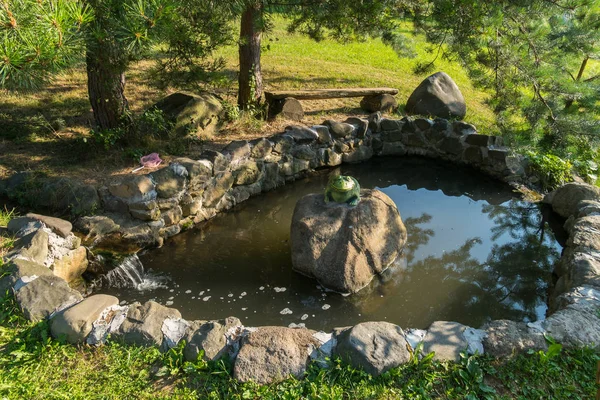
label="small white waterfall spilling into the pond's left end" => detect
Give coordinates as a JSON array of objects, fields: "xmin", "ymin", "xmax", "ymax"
[{"xmin": 103, "ymin": 254, "xmax": 169, "ymax": 291}]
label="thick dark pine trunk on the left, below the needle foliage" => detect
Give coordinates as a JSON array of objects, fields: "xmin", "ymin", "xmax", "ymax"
[{"xmin": 86, "ymin": 46, "xmax": 128, "ymax": 129}]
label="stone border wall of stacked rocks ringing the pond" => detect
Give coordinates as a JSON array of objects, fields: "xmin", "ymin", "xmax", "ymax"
[{"xmin": 0, "ymin": 115, "xmax": 600, "ymax": 383}]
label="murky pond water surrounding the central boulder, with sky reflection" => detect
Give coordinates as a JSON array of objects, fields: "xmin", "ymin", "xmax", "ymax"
[{"xmin": 97, "ymin": 158, "xmax": 561, "ymax": 330}]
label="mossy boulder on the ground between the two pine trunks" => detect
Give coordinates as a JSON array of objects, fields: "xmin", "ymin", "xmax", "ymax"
[{"xmin": 151, "ymin": 92, "xmax": 224, "ymax": 136}]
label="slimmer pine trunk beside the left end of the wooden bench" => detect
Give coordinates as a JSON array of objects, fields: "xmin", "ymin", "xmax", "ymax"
[{"xmin": 238, "ymin": 1, "xmax": 263, "ymax": 109}]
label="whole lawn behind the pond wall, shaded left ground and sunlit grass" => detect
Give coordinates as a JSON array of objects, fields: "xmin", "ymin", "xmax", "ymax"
[{"xmin": 0, "ymin": 18, "xmax": 494, "ymax": 184}]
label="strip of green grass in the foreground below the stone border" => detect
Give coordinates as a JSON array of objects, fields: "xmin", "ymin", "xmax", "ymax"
[{"xmin": 0, "ymin": 292, "xmax": 600, "ymax": 399}]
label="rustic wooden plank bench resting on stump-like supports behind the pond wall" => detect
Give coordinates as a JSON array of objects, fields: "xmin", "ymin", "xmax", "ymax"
[{"xmin": 264, "ymin": 88, "xmax": 398, "ymax": 121}]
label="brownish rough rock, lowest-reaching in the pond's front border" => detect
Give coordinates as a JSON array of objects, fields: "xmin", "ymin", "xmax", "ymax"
[{"xmin": 233, "ymin": 326, "xmax": 319, "ymax": 384}]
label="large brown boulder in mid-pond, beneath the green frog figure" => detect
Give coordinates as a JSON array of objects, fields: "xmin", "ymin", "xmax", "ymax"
[{"xmin": 291, "ymin": 190, "xmax": 406, "ymax": 293}]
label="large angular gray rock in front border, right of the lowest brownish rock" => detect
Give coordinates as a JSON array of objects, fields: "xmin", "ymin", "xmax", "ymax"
[{"xmin": 333, "ymin": 322, "xmax": 410, "ymax": 376}]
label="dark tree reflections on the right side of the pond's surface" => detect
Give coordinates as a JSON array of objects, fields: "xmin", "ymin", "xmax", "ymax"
[{"xmin": 384, "ymin": 200, "xmax": 560, "ymax": 322}]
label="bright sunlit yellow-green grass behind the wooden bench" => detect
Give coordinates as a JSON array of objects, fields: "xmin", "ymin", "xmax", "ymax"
[{"xmin": 217, "ymin": 17, "xmax": 496, "ymax": 133}]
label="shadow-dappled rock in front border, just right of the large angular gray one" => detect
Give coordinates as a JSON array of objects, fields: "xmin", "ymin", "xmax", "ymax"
[{"xmin": 423, "ymin": 321, "xmax": 469, "ymax": 362}]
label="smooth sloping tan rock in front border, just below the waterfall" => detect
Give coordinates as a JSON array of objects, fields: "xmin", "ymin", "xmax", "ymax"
[{"xmin": 50, "ymin": 294, "xmax": 119, "ymax": 343}]
